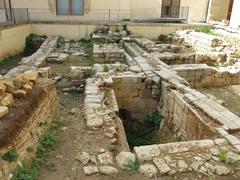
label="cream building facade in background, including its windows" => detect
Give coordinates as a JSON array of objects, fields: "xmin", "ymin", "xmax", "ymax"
[{"xmin": 0, "ymin": 0, "xmax": 208, "ymax": 22}]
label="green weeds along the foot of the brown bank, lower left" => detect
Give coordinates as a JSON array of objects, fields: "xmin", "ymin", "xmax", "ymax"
[{"xmin": 12, "ymin": 119, "xmax": 59, "ymax": 180}]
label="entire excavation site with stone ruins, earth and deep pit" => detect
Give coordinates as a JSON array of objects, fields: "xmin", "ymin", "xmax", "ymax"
[{"xmin": 0, "ymin": 24, "xmax": 240, "ymax": 180}]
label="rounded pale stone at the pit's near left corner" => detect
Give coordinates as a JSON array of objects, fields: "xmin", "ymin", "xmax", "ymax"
[{"xmin": 116, "ymin": 152, "xmax": 136, "ymax": 169}]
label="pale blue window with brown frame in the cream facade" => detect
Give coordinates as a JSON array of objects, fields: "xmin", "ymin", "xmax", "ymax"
[{"xmin": 57, "ymin": 0, "xmax": 84, "ymax": 15}]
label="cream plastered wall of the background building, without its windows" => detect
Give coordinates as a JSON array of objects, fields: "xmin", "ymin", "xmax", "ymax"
[{"xmin": 12, "ymin": 0, "xmax": 208, "ymax": 22}]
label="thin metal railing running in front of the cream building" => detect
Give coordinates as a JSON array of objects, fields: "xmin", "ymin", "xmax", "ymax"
[{"xmin": 0, "ymin": 7, "xmax": 189, "ymax": 24}]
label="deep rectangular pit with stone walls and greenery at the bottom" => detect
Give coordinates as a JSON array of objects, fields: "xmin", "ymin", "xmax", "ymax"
[{"xmin": 112, "ymin": 75, "xmax": 219, "ymax": 149}]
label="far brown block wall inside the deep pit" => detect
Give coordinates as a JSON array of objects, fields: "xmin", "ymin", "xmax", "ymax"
[{"xmin": 113, "ymin": 75, "xmax": 158, "ymax": 121}]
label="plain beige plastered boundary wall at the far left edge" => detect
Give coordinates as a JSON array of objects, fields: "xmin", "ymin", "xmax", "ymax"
[{"xmin": 0, "ymin": 24, "xmax": 32, "ymax": 60}]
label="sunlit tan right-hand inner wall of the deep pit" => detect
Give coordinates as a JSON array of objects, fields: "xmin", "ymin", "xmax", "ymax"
[{"xmin": 159, "ymin": 82, "xmax": 217, "ymax": 141}]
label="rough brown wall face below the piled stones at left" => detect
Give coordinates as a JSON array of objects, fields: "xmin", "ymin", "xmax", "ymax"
[{"xmin": 0, "ymin": 79, "xmax": 59, "ymax": 179}]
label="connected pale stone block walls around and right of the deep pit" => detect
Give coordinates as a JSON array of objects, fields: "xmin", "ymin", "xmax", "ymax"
[{"xmin": 78, "ymin": 27, "xmax": 240, "ymax": 177}]
